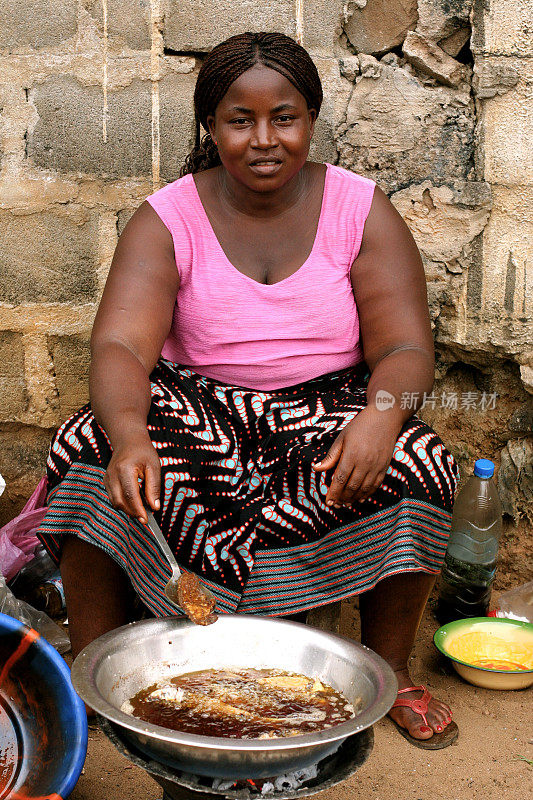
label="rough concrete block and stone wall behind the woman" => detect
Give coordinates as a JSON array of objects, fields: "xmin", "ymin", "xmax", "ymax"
[{"xmin": 0, "ymin": 0, "xmax": 533, "ymax": 544}]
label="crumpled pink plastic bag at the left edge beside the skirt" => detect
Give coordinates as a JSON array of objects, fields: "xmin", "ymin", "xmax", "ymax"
[{"xmin": 0, "ymin": 477, "xmax": 47, "ymax": 580}]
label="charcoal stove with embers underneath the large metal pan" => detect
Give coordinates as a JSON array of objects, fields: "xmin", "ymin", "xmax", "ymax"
[{"xmin": 99, "ymin": 717, "xmax": 374, "ymax": 800}]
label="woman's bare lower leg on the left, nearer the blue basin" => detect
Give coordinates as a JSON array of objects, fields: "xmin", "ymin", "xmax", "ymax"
[{"xmin": 60, "ymin": 536, "xmax": 130, "ymax": 658}]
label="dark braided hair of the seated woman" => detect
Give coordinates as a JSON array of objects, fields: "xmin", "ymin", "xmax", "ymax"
[{"xmin": 180, "ymin": 33, "xmax": 322, "ymax": 177}]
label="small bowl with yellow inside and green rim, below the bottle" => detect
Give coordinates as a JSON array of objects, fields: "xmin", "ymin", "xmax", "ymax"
[{"xmin": 433, "ymin": 617, "xmax": 533, "ymax": 689}]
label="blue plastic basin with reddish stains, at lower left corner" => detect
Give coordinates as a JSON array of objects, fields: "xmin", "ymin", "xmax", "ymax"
[{"xmin": 0, "ymin": 614, "xmax": 87, "ymax": 800}]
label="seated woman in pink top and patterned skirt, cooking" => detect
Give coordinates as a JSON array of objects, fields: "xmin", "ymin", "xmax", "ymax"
[{"xmin": 40, "ymin": 33, "xmax": 457, "ymax": 747}]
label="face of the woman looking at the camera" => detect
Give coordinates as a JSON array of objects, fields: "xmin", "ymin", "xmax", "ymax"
[{"xmin": 207, "ymin": 64, "xmax": 316, "ymax": 192}]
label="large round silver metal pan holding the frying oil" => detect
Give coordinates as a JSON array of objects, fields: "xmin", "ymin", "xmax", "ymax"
[{"xmin": 72, "ymin": 615, "xmax": 397, "ymax": 778}]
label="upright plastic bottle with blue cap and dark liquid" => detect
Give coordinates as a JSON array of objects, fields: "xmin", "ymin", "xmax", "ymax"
[{"xmin": 437, "ymin": 458, "xmax": 502, "ymax": 625}]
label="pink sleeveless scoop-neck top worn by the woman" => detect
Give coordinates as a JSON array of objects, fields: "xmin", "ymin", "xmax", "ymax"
[{"xmin": 147, "ymin": 164, "xmax": 375, "ymax": 391}]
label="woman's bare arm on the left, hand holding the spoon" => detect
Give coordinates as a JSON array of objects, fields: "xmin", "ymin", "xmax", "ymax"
[{"xmin": 89, "ymin": 202, "xmax": 179, "ymax": 522}]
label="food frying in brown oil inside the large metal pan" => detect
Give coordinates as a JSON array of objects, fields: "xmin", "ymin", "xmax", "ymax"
[{"xmin": 122, "ymin": 669, "xmax": 362, "ymax": 739}]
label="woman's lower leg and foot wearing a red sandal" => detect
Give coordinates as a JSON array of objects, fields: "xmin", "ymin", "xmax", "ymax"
[{"xmin": 359, "ymin": 572, "xmax": 451, "ymax": 739}]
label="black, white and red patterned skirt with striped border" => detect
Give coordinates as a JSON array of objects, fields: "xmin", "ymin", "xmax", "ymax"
[{"xmin": 39, "ymin": 359, "xmax": 457, "ymax": 616}]
